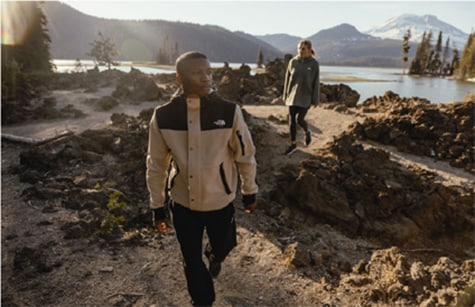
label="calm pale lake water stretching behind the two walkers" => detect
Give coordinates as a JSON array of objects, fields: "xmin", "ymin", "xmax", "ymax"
[{"xmin": 53, "ymin": 60, "xmax": 475, "ymax": 103}]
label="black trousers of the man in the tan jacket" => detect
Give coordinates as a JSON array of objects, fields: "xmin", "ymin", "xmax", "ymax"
[{"xmin": 171, "ymin": 203, "xmax": 237, "ymax": 306}]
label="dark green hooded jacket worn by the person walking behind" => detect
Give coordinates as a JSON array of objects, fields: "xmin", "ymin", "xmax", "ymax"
[{"xmin": 282, "ymin": 56, "xmax": 320, "ymax": 108}]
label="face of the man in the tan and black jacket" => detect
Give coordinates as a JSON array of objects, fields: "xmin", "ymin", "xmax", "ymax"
[{"xmin": 177, "ymin": 59, "xmax": 213, "ymax": 97}]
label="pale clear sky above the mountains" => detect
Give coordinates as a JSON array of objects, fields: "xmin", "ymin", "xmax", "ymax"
[{"xmin": 60, "ymin": 0, "xmax": 475, "ymax": 38}]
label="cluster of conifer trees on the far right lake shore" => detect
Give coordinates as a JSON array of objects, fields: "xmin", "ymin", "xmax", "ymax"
[{"xmin": 402, "ymin": 29, "xmax": 475, "ymax": 80}]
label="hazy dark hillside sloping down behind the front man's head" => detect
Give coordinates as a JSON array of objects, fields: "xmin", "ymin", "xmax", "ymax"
[{"xmin": 44, "ymin": 1, "xmax": 283, "ymax": 63}]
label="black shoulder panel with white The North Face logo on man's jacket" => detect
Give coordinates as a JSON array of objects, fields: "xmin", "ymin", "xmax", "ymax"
[{"xmin": 201, "ymin": 93, "xmax": 236, "ymax": 131}]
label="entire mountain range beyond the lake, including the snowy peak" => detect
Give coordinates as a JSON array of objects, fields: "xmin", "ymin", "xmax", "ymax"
[{"xmin": 44, "ymin": 1, "xmax": 468, "ymax": 67}]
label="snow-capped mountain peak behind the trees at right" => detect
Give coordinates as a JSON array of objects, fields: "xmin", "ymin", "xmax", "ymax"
[{"xmin": 363, "ymin": 14, "xmax": 468, "ymax": 50}]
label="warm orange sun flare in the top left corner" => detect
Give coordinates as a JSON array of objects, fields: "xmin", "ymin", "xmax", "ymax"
[{"xmin": 1, "ymin": 1, "xmax": 33, "ymax": 45}]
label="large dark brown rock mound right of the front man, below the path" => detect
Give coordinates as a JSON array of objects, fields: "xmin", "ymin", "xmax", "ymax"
[{"xmin": 270, "ymin": 135, "xmax": 475, "ymax": 253}]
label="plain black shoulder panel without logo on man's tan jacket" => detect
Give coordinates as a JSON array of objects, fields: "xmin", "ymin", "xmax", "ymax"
[{"xmin": 155, "ymin": 96, "xmax": 187, "ymax": 131}]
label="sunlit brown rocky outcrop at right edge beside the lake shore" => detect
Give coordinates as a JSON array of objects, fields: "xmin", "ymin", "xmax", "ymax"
[{"xmin": 354, "ymin": 92, "xmax": 475, "ymax": 174}]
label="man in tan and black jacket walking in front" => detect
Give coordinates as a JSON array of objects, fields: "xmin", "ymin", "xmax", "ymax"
[{"xmin": 147, "ymin": 51, "xmax": 258, "ymax": 306}]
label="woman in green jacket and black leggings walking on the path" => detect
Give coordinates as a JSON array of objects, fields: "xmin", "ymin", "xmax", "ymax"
[{"xmin": 283, "ymin": 40, "xmax": 320, "ymax": 155}]
